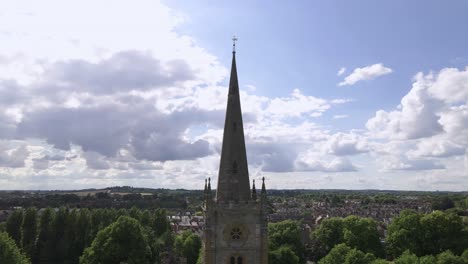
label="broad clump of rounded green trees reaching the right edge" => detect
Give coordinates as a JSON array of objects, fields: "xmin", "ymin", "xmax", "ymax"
[{"xmin": 308, "ymin": 210, "xmax": 468, "ymax": 264}]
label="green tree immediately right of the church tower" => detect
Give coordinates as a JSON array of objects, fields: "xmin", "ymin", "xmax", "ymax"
[{"xmin": 268, "ymin": 220, "xmax": 305, "ymax": 263}]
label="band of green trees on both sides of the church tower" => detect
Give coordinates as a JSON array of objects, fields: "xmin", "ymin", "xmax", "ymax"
[{"xmin": 0, "ymin": 207, "xmax": 468, "ymax": 264}]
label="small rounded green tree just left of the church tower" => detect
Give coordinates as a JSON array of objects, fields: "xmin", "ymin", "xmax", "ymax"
[{"xmin": 174, "ymin": 231, "xmax": 201, "ymax": 264}]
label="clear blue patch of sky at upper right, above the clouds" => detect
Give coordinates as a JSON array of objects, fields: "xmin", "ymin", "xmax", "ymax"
[{"xmin": 167, "ymin": 0, "xmax": 468, "ymax": 129}]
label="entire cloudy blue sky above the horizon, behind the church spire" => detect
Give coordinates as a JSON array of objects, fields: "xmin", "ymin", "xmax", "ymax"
[{"xmin": 0, "ymin": 0, "xmax": 468, "ymax": 191}]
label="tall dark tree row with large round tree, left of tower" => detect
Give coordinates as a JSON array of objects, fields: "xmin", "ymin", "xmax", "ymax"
[{"xmin": 0, "ymin": 207, "xmax": 177, "ymax": 264}]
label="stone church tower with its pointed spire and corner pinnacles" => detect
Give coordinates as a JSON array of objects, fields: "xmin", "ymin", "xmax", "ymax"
[{"xmin": 203, "ymin": 38, "xmax": 268, "ymax": 264}]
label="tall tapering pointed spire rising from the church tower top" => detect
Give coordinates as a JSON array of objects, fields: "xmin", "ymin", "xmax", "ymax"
[{"xmin": 216, "ymin": 37, "xmax": 250, "ymax": 202}]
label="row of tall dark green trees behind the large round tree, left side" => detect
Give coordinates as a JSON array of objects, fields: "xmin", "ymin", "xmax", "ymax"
[{"xmin": 0, "ymin": 208, "xmax": 174, "ymax": 264}]
